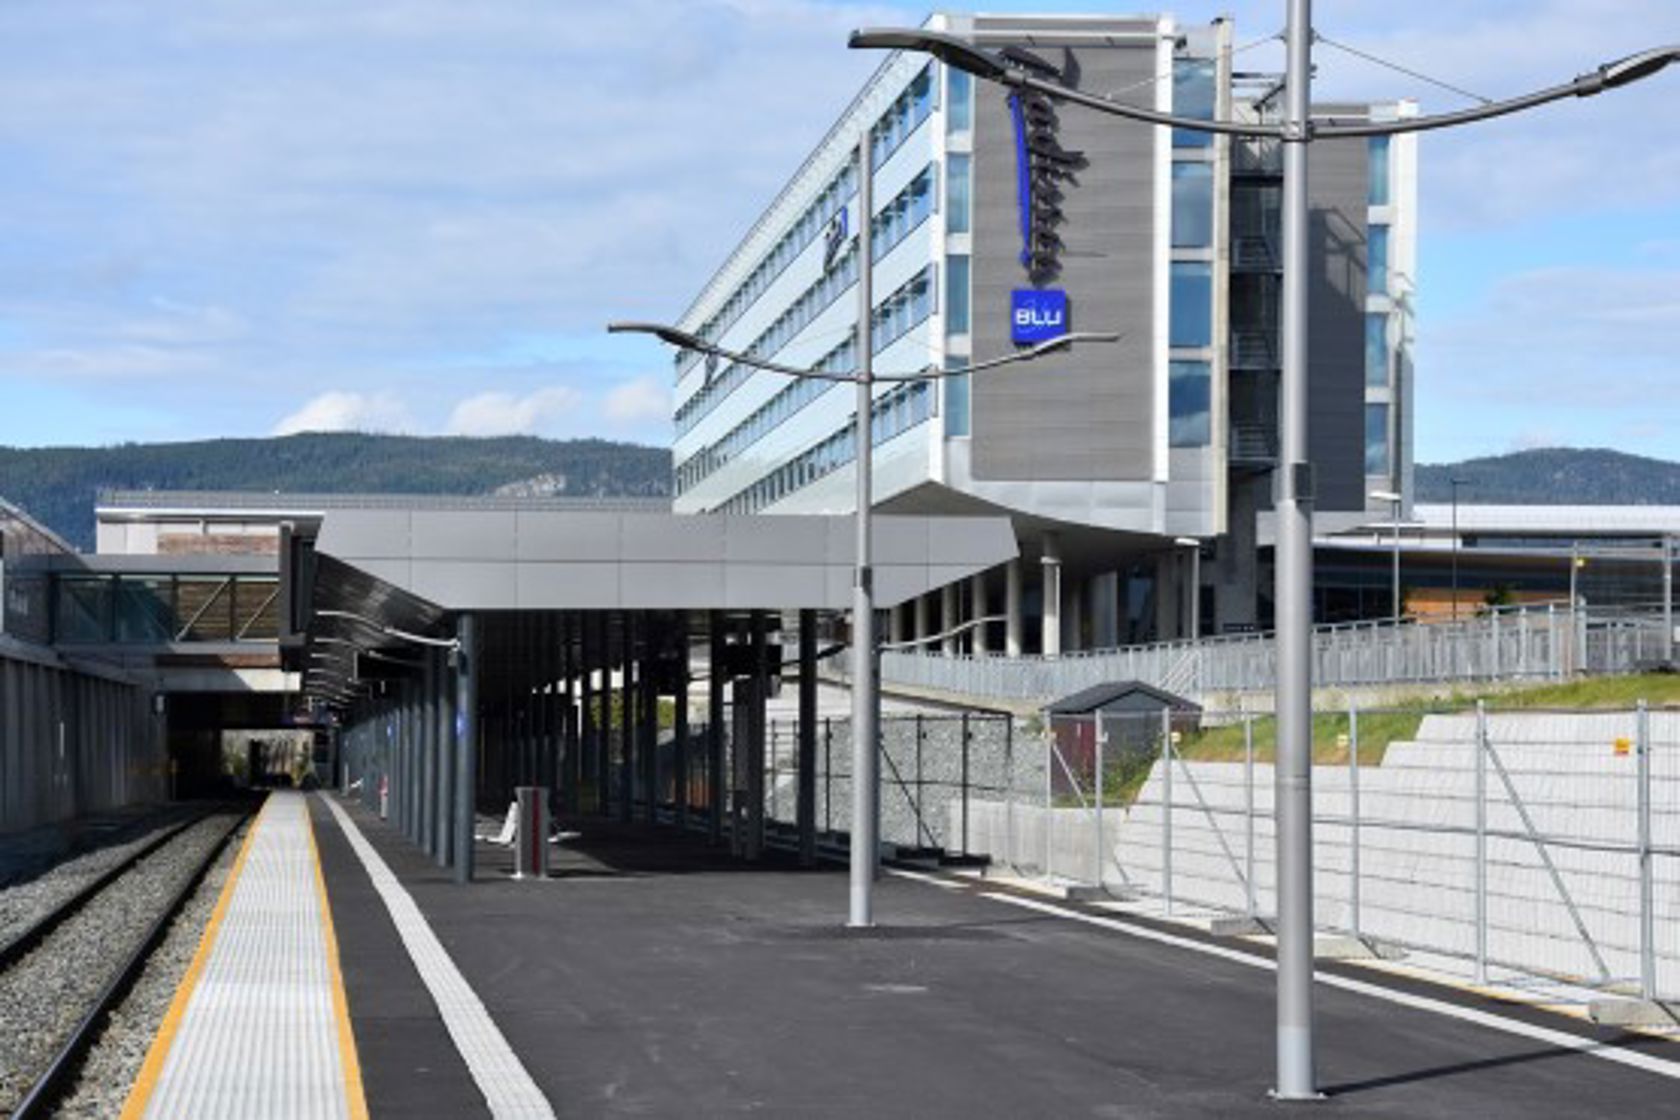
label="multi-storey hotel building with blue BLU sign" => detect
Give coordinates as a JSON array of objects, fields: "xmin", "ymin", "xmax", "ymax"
[{"xmin": 674, "ymin": 15, "xmax": 1416, "ymax": 653}]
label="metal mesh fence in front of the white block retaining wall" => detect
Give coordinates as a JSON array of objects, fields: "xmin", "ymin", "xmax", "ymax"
[{"xmin": 969, "ymin": 705, "xmax": 1680, "ymax": 999}]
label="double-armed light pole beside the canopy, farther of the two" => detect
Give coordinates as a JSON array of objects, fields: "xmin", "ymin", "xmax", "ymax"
[{"xmin": 606, "ymin": 126, "xmax": 1121, "ymax": 927}]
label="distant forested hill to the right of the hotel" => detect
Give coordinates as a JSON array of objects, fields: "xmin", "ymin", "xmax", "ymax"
[{"xmin": 1416, "ymin": 447, "xmax": 1680, "ymax": 505}]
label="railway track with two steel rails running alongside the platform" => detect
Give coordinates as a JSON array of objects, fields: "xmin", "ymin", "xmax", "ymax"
[{"xmin": 0, "ymin": 806, "xmax": 250, "ymax": 1120}]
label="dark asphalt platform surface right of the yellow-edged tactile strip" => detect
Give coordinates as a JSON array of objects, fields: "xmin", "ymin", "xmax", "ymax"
[{"xmin": 318, "ymin": 806, "xmax": 1680, "ymax": 1120}]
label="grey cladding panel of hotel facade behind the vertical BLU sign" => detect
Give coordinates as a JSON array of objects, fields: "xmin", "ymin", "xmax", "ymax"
[{"xmin": 969, "ymin": 34, "xmax": 1158, "ymax": 480}]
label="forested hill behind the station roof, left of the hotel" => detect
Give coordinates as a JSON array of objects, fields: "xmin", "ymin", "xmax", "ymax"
[{"xmin": 0, "ymin": 432, "xmax": 670, "ymax": 549}]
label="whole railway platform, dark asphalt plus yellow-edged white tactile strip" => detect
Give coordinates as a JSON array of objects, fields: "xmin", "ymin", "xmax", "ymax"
[{"xmin": 98, "ymin": 793, "xmax": 1680, "ymax": 1120}]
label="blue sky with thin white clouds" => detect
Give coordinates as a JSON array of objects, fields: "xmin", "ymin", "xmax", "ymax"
[{"xmin": 0, "ymin": 0, "xmax": 1680, "ymax": 463}]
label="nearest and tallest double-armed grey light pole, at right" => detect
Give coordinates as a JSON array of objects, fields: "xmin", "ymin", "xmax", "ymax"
[{"xmin": 850, "ymin": 17, "xmax": 1680, "ymax": 1100}]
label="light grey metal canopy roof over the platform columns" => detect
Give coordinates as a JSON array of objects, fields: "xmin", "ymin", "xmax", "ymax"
[{"xmin": 281, "ymin": 510, "xmax": 1016, "ymax": 708}]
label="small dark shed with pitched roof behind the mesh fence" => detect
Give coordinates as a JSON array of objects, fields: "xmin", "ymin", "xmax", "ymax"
[{"xmin": 1045, "ymin": 680, "xmax": 1201, "ymax": 793}]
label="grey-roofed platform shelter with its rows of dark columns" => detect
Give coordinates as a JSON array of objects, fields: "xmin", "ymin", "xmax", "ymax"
[{"xmin": 279, "ymin": 509, "xmax": 1016, "ymax": 882}]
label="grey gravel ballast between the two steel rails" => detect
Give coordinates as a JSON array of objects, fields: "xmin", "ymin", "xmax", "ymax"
[{"xmin": 0, "ymin": 814, "xmax": 245, "ymax": 1115}]
